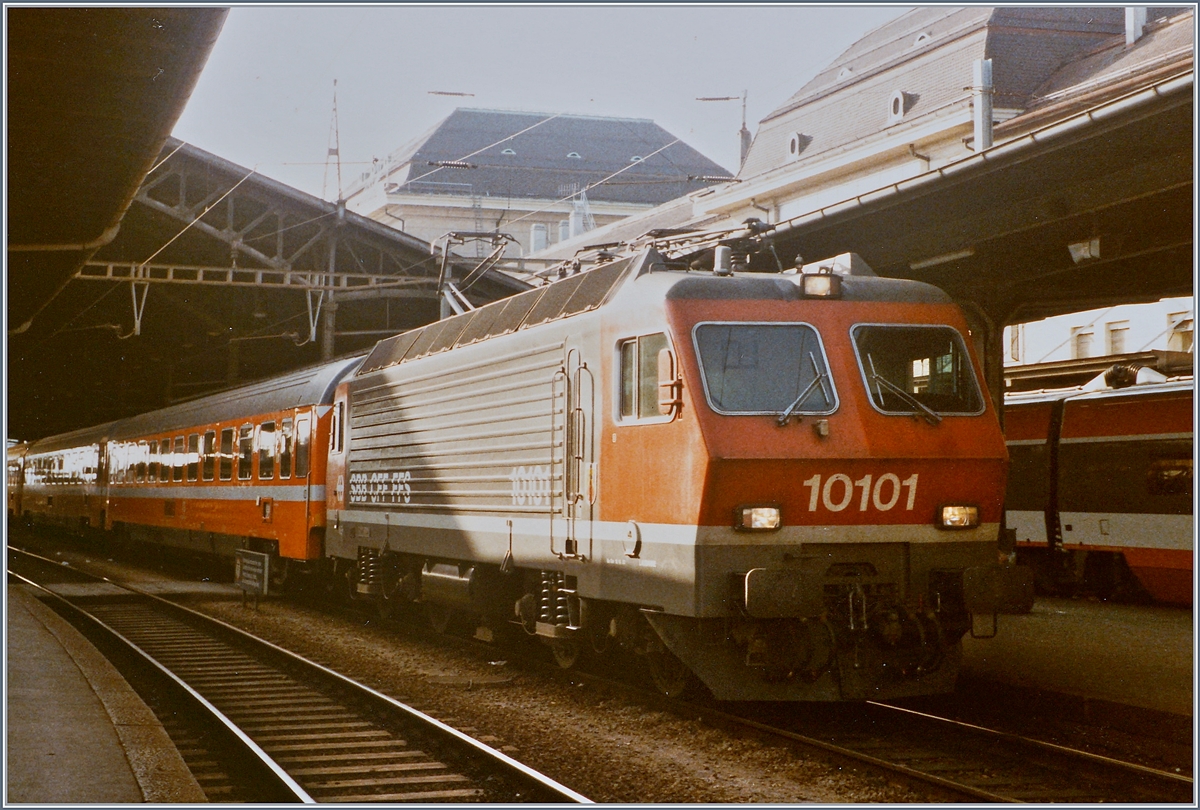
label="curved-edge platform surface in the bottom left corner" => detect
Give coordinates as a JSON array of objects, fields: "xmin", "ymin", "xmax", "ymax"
[{"xmin": 5, "ymin": 583, "xmax": 206, "ymax": 805}]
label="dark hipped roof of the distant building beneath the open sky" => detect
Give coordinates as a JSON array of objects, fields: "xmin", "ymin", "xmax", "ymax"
[{"xmin": 379, "ymin": 109, "xmax": 730, "ymax": 205}]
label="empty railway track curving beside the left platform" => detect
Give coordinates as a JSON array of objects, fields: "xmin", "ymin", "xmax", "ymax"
[{"xmin": 8, "ymin": 547, "xmax": 588, "ymax": 803}]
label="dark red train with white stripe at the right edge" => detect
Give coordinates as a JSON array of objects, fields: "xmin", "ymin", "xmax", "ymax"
[{"xmin": 1004, "ymin": 371, "xmax": 1195, "ymax": 605}]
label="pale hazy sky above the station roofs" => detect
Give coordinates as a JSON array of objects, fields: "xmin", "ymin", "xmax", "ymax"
[{"xmin": 174, "ymin": 4, "xmax": 908, "ymax": 199}]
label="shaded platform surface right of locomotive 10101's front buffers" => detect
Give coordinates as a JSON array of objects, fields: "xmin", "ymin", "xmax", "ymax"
[{"xmin": 962, "ymin": 598, "xmax": 1195, "ymax": 718}]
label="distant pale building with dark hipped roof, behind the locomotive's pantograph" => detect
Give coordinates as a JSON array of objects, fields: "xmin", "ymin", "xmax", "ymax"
[{"xmin": 346, "ymin": 108, "xmax": 732, "ymax": 257}]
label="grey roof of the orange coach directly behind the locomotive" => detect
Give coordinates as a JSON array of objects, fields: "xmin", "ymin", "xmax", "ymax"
[{"xmin": 107, "ymin": 355, "xmax": 362, "ymax": 446}]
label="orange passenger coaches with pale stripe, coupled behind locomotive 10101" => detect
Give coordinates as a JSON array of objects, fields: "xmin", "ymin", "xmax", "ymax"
[{"xmin": 10, "ymin": 356, "xmax": 362, "ymax": 572}]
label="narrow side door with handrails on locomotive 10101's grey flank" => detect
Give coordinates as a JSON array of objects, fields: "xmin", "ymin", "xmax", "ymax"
[{"xmin": 550, "ymin": 349, "xmax": 596, "ymax": 559}]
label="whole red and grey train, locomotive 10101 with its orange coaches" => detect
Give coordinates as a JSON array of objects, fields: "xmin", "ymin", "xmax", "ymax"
[{"xmin": 8, "ymin": 243, "xmax": 1009, "ymax": 701}]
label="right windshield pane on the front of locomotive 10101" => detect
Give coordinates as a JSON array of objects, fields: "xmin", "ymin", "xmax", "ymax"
[{"xmin": 851, "ymin": 324, "xmax": 984, "ymax": 421}]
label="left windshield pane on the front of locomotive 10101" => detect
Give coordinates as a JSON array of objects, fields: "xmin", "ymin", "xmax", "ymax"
[{"xmin": 692, "ymin": 323, "xmax": 838, "ymax": 415}]
